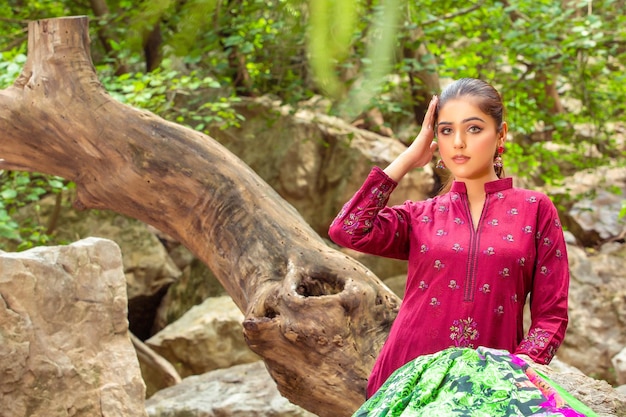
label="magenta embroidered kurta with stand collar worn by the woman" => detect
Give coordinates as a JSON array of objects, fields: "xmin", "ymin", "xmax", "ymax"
[{"xmin": 329, "ymin": 167, "xmax": 569, "ymax": 397}]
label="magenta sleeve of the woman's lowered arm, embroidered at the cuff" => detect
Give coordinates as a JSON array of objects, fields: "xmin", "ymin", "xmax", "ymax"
[{"xmin": 515, "ymin": 197, "xmax": 569, "ymax": 364}]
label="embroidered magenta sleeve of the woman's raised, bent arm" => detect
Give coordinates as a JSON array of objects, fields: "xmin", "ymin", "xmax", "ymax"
[{"xmin": 328, "ymin": 167, "xmax": 410, "ymax": 259}]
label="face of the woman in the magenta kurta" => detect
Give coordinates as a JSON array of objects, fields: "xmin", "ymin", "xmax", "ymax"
[{"xmin": 437, "ymin": 97, "xmax": 507, "ymax": 182}]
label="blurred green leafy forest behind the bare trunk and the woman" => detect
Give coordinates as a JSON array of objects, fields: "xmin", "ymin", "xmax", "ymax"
[{"xmin": 0, "ymin": 0, "xmax": 626, "ymax": 250}]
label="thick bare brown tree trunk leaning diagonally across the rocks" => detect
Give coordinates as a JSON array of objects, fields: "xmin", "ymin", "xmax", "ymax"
[{"xmin": 0, "ymin": 17, "xmax": 399, "ymax": 417}]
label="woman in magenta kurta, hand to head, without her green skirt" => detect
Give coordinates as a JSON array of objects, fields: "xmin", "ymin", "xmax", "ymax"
[{"xmin": 329, "ymin": 79, "xmax": 569, "ymax": 397}]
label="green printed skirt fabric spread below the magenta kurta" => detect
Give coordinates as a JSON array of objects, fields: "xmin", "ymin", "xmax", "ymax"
[{"xmin": 353, "ymin": 347, "xmax": 596, "ymax": 417}]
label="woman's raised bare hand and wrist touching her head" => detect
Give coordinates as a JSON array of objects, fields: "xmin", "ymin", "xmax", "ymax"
[{"xmin": 385, "ymin": 96, "xmax": 439, "ymax": 182}]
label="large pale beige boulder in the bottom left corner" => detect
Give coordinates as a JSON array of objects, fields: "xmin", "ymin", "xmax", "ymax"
[{"xmin": 0, "ymin": 238, "xmax": 146, "ymax": 417}]
